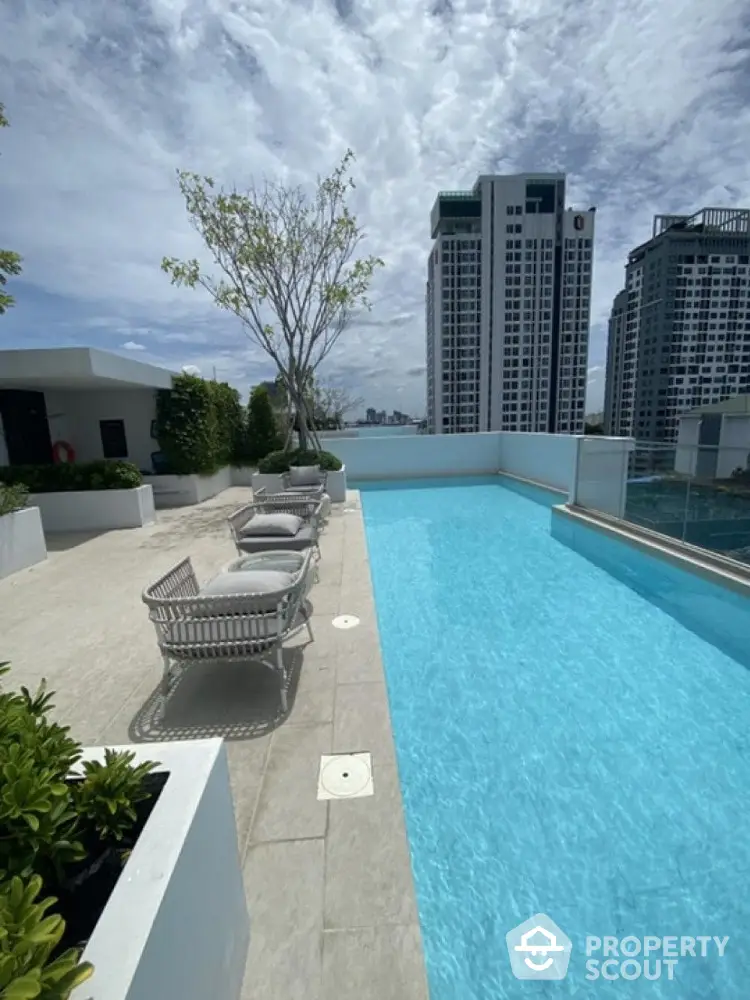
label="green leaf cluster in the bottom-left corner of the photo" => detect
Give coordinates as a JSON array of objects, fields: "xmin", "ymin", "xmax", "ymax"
[{"xmin": 0, "ymin": 875, "xmax": 94, "ymax": 1000}]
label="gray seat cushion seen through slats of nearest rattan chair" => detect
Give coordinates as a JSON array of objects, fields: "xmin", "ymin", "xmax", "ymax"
[{"xmin": 160, "ymin": 615, "xmax": 279, "ymax": 659}]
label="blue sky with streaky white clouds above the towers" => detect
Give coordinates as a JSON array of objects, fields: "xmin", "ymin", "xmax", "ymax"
[{"xmin": 0, "ymin": 0, "xmax": 750, "ymax": 414}]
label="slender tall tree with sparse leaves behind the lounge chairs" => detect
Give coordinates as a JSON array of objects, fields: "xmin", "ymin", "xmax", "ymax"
[{"xmin": 162, "ymin": 150, "xmax": 383, "ymax": 447}]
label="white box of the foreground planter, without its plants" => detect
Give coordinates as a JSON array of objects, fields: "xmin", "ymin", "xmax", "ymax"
[{"xmin": 72, "ymin": 739, "xmax": 250, "ymax": 1000}]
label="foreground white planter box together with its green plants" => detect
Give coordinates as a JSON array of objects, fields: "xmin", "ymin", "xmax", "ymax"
[{"xmin": 0, "ymin": 664, "xmax": 253, "ymax": 1000}]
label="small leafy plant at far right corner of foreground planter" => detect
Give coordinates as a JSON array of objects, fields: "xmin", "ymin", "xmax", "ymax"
[{"xmin": 73, "ymin": 750, "xmax": 156, "ymax": 841}]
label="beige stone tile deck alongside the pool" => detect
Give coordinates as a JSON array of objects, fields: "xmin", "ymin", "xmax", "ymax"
[{"xmin": 0, "ymin": 487, "xmax": 428, "ymax": 1000}]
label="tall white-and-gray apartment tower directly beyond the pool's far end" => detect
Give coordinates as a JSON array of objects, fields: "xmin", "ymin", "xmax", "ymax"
[{"xmin": 425, "ymin": 174, "xmax": 595, "ymax": 434}]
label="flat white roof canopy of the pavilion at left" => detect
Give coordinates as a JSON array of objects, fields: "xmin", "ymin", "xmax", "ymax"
[{"xmin": 0, "ymin": 347, "xmax": 174, "ymax": 390}]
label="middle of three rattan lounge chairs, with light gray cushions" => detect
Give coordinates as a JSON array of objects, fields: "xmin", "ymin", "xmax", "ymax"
[{"xmin": 227, "ymin": 498, "xmax": 321, "ymax": 556}]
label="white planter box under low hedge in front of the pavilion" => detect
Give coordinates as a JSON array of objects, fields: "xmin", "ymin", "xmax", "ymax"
[{"xmin": 29, "ymin": 485, "xmax": 155, "ymax": 531}]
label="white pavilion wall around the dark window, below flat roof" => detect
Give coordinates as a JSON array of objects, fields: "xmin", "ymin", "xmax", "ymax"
[{"xmin": 44, "ymin": 389, "xmax": 159, "ymax": 471}]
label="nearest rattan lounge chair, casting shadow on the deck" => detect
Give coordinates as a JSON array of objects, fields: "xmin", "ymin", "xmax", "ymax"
[{"xmin": 143, "ymin": 551, "xmax": 313, "ymax": 712}]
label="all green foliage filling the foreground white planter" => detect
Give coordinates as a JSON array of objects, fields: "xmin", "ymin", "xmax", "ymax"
[{"xmin": 0, "ymin": 663, "xmax": 163, "ymax": 1000}]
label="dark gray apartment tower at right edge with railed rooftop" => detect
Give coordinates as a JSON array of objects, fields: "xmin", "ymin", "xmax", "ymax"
[{"xmin": 604, "ymin": 208, "xmax": 750, "ymax": 442}]
